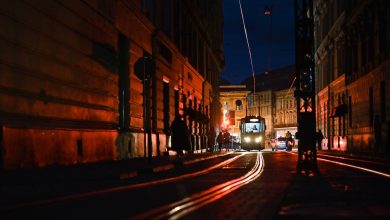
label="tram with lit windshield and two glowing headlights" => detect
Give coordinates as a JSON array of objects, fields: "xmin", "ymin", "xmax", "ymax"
[{"xmin": 240, "ymin": 116, "xmax": 266, "ymax": 151}]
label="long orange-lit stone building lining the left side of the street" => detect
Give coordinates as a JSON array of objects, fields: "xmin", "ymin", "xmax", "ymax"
[{"xmin": 0, "ymin": 0, "xmax": 224, "ymax": 168}]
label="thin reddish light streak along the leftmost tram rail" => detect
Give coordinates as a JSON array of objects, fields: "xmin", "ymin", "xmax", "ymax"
[{"xmin": 0, "ymin": 154, "xmax": 245, "ymax": 211}]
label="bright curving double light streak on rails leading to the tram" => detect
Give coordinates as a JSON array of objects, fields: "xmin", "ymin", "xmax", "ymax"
[{"xmin": 131, "ymin": 152, "xmax": 264, "ymax": 219}]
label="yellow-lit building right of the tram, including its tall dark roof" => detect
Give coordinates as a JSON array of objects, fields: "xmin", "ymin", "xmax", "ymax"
[{"xmin": 244, "ymin": 65, "xmax": 297, "ymax": 138}]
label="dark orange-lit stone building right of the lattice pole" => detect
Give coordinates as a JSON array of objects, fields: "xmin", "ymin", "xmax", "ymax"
[{"xmin": 314, "ymin": 0, "xmax": 390, "ymax": 155}]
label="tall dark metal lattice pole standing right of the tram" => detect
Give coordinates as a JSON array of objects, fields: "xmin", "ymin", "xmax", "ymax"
[{"xmin": 294, "ymin": 0, "xmax": 317, "ymax": 171}]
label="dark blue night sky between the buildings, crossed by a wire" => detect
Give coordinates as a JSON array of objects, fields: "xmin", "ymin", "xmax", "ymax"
[{"xmin": 221, "ymin": 0, "xmax": 295, "ymax": 84}]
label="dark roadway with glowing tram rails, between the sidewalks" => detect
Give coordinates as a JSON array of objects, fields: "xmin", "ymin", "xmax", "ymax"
[{"xmin": 0, "ymin": 151, "xmax": 390, "ymax": 219}]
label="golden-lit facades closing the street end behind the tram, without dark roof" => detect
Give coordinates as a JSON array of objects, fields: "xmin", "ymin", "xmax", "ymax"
[{"xmin": 220, "ymin": 81, "xmax": 297, "ymax": 145}]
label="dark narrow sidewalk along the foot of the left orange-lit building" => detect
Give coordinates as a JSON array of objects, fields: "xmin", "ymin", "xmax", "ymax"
[{"xmin": 0, "ymin": 151, "xmax": 230, "ymax": 186}]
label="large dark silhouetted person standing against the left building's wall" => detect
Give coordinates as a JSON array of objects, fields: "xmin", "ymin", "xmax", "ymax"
[{"xmin": 171, "ymin": 115, "xmax": 191, "ymax": 155}]
